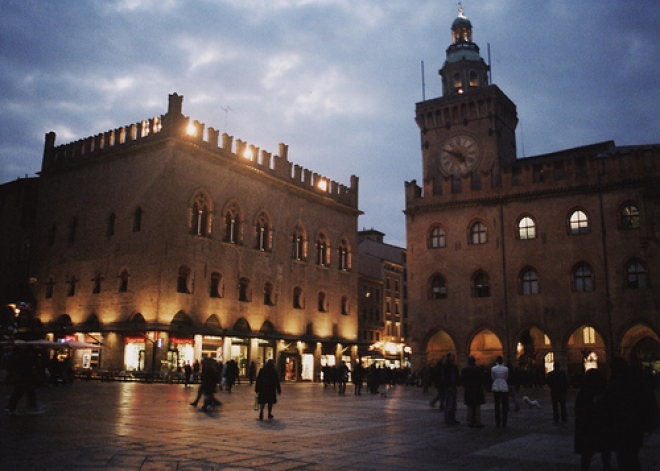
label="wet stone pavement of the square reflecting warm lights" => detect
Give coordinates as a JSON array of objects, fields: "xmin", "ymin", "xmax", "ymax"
[{"xmin": 0, "ymin": 381, "xmax": 660, "ymax": 471}]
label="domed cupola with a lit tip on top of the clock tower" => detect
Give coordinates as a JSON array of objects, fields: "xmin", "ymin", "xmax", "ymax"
[{"xmin": 439, "ymin": 4, "xmax": 490, "ymax": 96}]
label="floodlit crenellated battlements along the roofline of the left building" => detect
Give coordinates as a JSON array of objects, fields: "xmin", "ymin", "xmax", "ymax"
[{"xmin": 41, "ymin": 93, "xmax": 359, "ymax": 209}]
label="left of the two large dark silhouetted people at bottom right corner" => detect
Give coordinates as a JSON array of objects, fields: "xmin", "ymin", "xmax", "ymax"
[{"xmin": 574, "ymin": 368, "xmax": 614, "ymax": 471}]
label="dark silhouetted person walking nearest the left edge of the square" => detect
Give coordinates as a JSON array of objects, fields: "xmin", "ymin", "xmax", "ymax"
[{"xmin": 5, "ymin": 346, "xmax": 44, "ymax": 415}]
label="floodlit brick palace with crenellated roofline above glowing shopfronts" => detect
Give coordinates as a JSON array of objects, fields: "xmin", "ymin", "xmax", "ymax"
[{"xmin": 31, "ymin": 94, "xmax": 360, "ymax": 380}]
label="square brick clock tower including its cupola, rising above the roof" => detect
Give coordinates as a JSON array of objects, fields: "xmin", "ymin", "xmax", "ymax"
[{"xmin": 415, "ymin": 7, "xmax": 518, "ymax": 184}]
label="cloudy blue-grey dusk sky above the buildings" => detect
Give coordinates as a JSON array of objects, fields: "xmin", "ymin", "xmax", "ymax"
[{"xmin": 0, "ymin": 0, "xmax": 660, "ymax": 247}]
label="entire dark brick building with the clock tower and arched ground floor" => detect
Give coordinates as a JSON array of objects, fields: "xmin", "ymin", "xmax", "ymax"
[{"xmin": 405, "ymin": 7, "xmax": 660, "ymax": 376}]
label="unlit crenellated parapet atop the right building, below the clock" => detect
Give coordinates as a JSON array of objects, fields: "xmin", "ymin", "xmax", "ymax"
[{"xmin": 406, "ymin": 141, "xmax": 660, "ymax": 208}]
